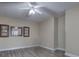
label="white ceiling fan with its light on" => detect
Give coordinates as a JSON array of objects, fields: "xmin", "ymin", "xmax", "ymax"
[{"xmin": 21, "ymin": 2, "xmax": 43, "ymax": 15}]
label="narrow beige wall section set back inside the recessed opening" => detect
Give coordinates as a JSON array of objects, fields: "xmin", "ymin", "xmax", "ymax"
[{"xmin": 58, "ymin": 15, "xmax": 65, "ymax": 49}]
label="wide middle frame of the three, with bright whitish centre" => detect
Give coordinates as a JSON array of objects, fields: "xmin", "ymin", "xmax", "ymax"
[{"xmin": 10, "ymin": 26, "xmax": 22, "ymax": 36}]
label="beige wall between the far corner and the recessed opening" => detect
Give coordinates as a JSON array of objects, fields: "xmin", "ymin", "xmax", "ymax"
[{"xmin": 40, "ymin": 16, "xmax": 54, "ymax": 49}]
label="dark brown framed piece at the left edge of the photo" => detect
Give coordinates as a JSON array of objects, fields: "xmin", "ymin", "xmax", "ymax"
[{"xmin": 0, "ymin": 24, "xmax": 9, "ymax": 37}]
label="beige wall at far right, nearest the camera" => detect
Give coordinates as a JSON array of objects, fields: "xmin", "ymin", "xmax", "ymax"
[{"xmin": 65, "ymin": 7, "xmax": 79, "ymax": 56}]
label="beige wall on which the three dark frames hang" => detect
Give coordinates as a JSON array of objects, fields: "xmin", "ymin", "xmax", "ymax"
[{"xmin": 0, "ymin": 17, "xmax": 39, "ymax": 50}]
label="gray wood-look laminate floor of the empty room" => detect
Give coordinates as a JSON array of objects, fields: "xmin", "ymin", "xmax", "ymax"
[{"xmin": 0, "ymin": 47, "xmax": 64, "ymax": 57}]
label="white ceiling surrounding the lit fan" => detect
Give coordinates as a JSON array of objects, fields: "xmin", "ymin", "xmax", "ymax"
[{"xmin": 0, "ymin": 2, "xmax": 79, "ymax": 22}]
